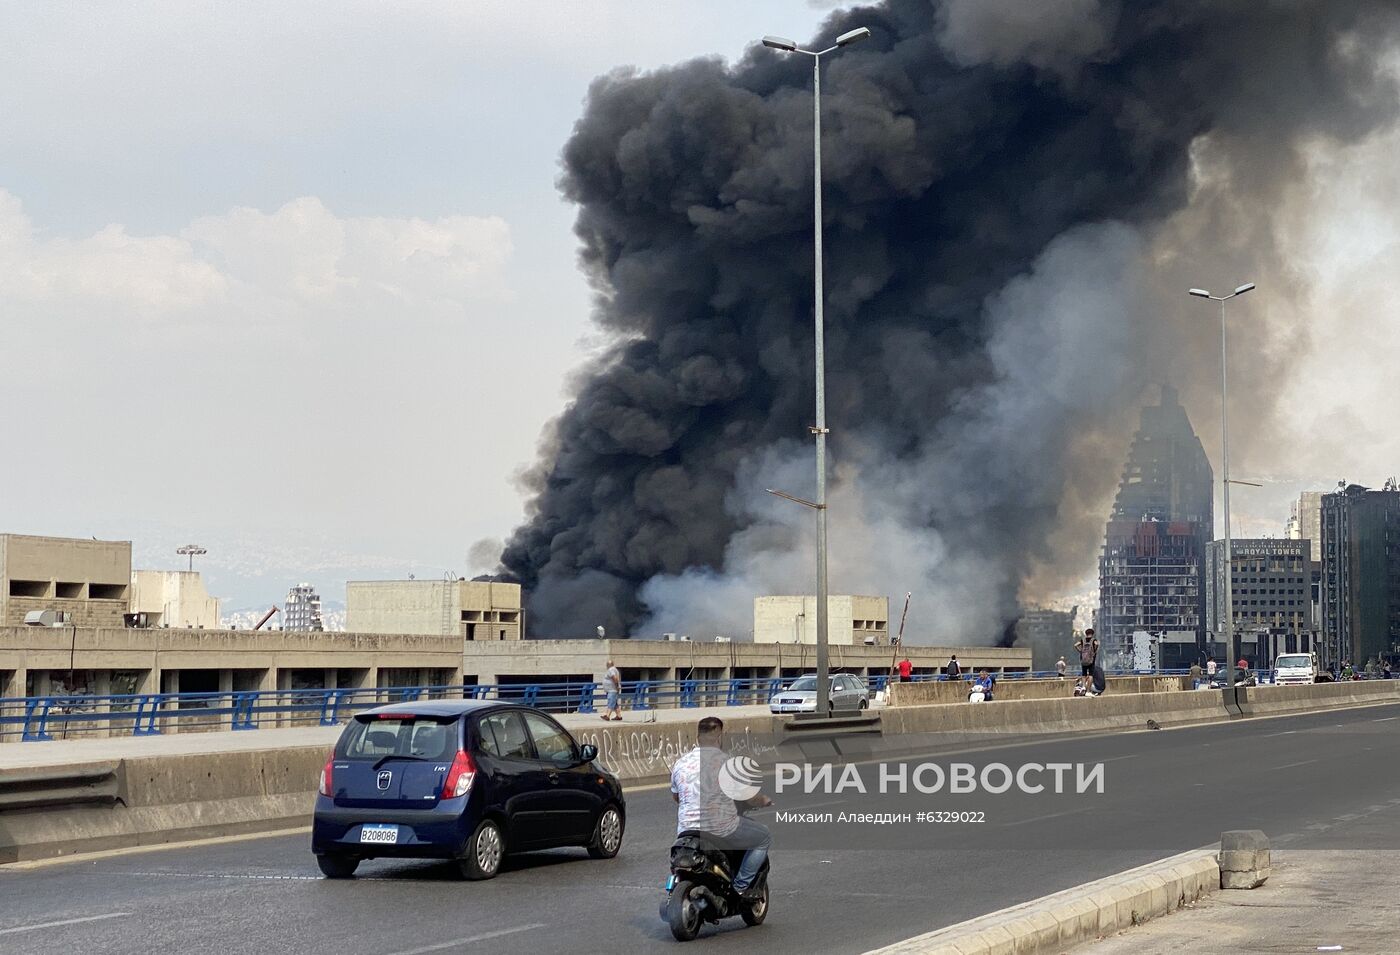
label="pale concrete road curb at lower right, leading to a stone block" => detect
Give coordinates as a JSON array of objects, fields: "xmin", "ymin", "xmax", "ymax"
[{"xmin": 865, "ymin": 847, "xmax": 1221, "ymax": 955}]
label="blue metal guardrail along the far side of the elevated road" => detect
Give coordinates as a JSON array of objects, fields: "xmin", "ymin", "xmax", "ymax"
[{"xmin": 0, "ymin": 669, "xmax": 1187, "ymax": 742}]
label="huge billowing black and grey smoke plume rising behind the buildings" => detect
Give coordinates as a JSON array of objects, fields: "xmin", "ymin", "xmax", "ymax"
[{"xmin": 503, "ymin": 0, "xmax": 1400, "ymax": 643}]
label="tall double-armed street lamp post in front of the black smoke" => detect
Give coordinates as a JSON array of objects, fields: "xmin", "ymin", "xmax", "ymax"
[{"xmin": 763, "ymin": 27, "xmax": 871, "ymax": 717}]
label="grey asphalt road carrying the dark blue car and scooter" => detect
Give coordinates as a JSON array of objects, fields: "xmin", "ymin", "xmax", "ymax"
[{"xmin": 0, "ymin": 704, "xmax": 1400, "ymax": 955}]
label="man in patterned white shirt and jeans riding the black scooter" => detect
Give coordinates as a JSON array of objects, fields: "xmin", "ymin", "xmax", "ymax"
[{"xmin": 671, "ymin": 717, "xmax": 773, "ymax": 895}]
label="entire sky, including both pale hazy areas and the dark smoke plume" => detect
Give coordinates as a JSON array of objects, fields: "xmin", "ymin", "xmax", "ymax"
[{"xmin": 0, "ymin": 0, "xmax": 1400, "ymax": 627}]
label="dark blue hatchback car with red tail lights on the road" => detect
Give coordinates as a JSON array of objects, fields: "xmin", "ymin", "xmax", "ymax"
[{"xmin": 311, "ymin": 700, "xmax": 626, "ymax": 879}]
